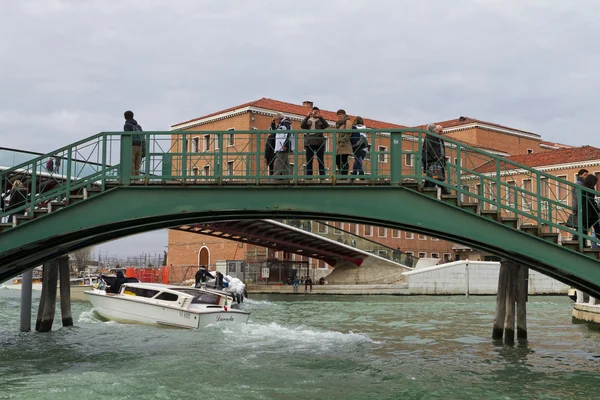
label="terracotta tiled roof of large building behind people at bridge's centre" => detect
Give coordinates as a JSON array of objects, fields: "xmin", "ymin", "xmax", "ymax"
[{"xmin": 172, "ymin": 97, "xmax": 406, "ymax": 129}]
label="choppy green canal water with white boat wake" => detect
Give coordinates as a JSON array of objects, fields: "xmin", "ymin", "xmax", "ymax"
[{"xmin": 0, "ymin": 289, "xmax": 600, "ymax": 400}]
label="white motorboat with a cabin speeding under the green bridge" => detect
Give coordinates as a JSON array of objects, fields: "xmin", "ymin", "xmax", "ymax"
[{"xmin": 84, "ymin": 283, "xmax": 250, "ymax": 329}]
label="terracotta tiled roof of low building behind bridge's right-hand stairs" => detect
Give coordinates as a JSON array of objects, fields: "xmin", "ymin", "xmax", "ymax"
[{"xmin": 477, "ymin": 146, "xmax": 600, "ymax": 172}]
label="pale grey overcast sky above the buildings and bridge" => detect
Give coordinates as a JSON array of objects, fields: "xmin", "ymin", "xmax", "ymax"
[{"xmin": 0, "ymin": 0, "xmax": 600, "ymax": 254}]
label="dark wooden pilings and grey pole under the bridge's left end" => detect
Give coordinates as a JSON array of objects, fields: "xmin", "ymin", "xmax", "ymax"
[{"xmin": 20, "ymin": 256, "xmax": 73, "ymax": 332}]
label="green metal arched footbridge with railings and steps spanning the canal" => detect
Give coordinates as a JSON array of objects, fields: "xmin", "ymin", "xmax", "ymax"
[{"xmin": 0, "ymin": 129, "xmax": 600, "ymax": 296}]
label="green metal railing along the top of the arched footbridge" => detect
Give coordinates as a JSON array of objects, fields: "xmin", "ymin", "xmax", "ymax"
[{"xmin": 0, "ymin": 129, "xmax": 598, "ymax": 250}]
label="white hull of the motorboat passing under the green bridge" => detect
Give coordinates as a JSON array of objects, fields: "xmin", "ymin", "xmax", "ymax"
[{"xmin": 84, "ymin": 291, "xmax": 250, "ymax": 329}]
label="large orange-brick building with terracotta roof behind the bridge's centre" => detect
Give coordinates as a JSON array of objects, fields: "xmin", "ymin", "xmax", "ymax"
[{"xmin": 168, "ymin": 98, "xmax": 580, "ymax": 276}]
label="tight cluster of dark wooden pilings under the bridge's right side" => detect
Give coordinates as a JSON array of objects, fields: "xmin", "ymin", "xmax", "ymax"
[{"xmin": 492, "ymin": 260, "xmax": 529, "ymax": 344}]
